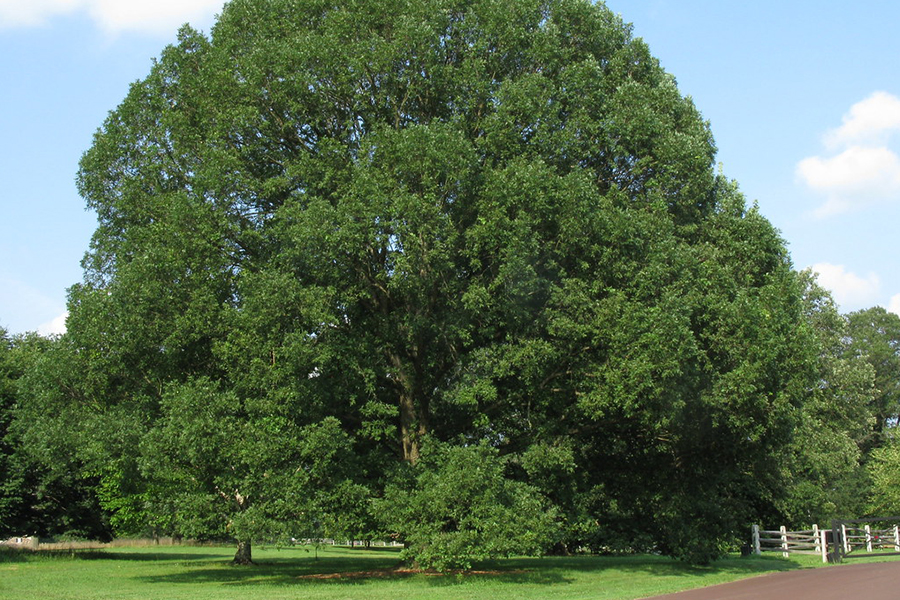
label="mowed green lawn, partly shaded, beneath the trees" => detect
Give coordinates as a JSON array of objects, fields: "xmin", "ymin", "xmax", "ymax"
[{"xmin": 0, "ymin": 546, "xmax": 817, "ymax": 600}]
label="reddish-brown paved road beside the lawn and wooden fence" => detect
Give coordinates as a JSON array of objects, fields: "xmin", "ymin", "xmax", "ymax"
[{"xmin": 648, "ymin": 562, "xmax": 900, "ymax": 600}]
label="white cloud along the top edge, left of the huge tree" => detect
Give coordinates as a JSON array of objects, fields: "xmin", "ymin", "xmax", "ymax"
[{"xmin": 0, "ymin": 0, "xmax": 224, "ymax": 34}]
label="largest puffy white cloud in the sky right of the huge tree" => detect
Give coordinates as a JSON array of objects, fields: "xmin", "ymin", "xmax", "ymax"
[{"xmin": 797, "ymin": 92, "xmax": 900, "ymax": 217}]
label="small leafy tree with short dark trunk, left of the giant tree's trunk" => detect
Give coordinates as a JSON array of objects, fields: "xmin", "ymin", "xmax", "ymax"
[{"xmin": 141, "ymin": 379, "xmax": 356, "ymax": 564}]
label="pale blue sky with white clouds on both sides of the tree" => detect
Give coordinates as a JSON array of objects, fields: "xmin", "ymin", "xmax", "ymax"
[{"xmin": 0, "ymin": 0, "xmax": 900, "ymax": 333}]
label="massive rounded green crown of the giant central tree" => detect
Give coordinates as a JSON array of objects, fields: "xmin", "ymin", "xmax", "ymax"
[{"xmin": 56, "ymin": 0, "xmax": 815, "ymax": 560}]
